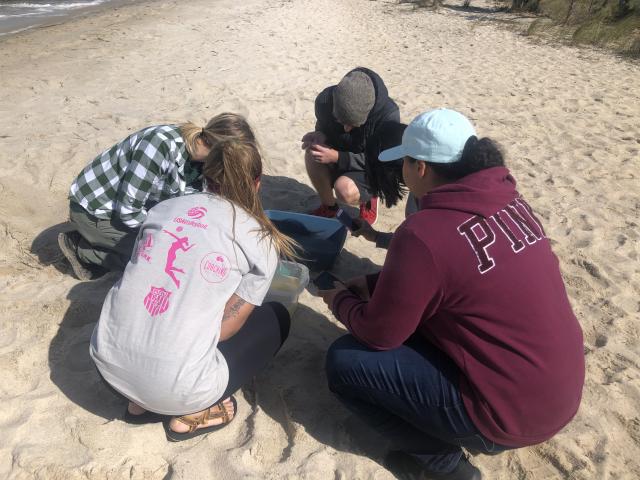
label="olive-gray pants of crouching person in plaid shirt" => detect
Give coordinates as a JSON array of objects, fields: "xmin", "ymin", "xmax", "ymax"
[{"xmin": 69, "ymin": 201, "xmax": 138, "ymax": 271}]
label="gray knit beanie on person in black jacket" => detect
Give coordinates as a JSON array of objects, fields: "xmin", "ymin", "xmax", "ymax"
[{"xmin": 333, "ymin": 70, "xmax": 376, "ymax": 127}]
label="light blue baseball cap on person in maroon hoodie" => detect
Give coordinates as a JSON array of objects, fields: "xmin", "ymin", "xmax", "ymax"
[{"xmin": 378, "ymin": 108, "xmax": 476, "ymax": 163}]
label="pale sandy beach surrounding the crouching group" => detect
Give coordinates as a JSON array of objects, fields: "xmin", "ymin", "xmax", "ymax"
[{"xmin": 0, "ymin": 0, "xmax": 640, "ymax": 480}]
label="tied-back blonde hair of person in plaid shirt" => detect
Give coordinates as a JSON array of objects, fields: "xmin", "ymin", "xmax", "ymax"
[{"xmin": 179, "ymin": 112, "xmax": 256, "ymax": 156}]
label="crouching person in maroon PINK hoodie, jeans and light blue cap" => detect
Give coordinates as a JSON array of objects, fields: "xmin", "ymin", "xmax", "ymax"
[{"xmin": 321, "ymin": 109, "xmax": 584, "ymax": 480}]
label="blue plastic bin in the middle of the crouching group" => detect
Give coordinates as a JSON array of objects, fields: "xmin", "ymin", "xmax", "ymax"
[{"xmin": 265, "ymin": 210, "xmax": 347, "ymax": 270}]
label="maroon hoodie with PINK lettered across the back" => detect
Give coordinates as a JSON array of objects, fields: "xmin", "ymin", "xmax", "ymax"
[{"xmin": 332, "ymin": 167, "xmax": 584, "ymax": 447}]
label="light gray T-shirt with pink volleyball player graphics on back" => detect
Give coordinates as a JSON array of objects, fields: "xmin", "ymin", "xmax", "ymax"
[{"xmin": 90, "ymin": 193, "xmax": 278, "ymax": 415}]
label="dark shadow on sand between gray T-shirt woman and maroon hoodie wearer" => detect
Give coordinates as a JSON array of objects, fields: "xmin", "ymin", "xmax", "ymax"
[{"xmin": 243, "ymin": 305, "xmax": 387, "ymax": 463}]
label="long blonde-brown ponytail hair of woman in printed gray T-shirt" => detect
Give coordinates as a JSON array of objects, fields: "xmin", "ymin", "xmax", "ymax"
[{"xmin": 202, "ymin": 140, "xmax": 299, "ymax": 259}]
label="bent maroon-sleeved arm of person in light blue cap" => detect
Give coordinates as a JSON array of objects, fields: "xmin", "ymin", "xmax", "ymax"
[{"xmin": 330, "ymin": 228, "xmax": 443, "ymax": 350}]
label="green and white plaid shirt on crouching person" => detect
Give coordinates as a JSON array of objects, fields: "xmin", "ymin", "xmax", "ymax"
[{"xmin": 69, "ymin": 125, "xmax": 195, "ymax": 228}]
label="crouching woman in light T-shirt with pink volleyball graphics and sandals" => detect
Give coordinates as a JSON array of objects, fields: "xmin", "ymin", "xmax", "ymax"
[{"xmin": 90, "ymin": 137, "xmax": 294, "ymax": 441}]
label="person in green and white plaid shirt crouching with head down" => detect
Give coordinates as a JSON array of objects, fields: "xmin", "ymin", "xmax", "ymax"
[{"xmin": 58, "ymin": 113, "xmax": 255, "ymax": 280}]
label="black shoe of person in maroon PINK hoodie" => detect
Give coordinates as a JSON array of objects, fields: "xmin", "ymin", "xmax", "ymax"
[{"xmin": 384, "ymin": 451, "xmax": 482, "ymax": 480}]
